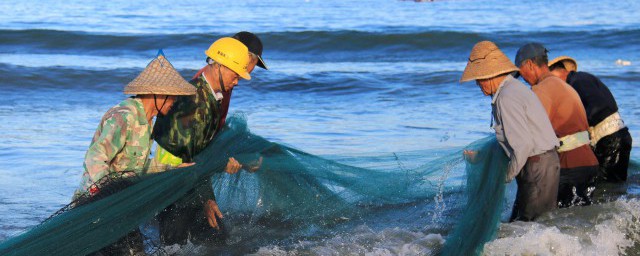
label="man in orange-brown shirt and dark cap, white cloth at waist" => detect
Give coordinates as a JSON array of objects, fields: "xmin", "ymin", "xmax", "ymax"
[{"xmin": 516, "ymin": 43, "xmax": 598, "ymax": 207}]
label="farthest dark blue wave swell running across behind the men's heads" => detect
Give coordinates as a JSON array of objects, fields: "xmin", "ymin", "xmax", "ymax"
[{"xmin": 0, "ymin": 28, "xmax": 640, "ymax": 61}]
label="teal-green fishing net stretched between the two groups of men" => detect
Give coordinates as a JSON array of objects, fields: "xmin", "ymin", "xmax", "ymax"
[{"xmin": 0, "ymin": 115, "xmax": 508, "ymax": 255}]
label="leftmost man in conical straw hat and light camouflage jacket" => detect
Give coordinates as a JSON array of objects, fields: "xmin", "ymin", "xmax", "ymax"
[{"xmin": 74, "ymin": 53, "xmax": 196, "ymax": 255}]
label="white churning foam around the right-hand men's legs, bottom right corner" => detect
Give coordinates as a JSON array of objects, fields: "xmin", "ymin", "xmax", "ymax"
[{"xmin": 484, "ymin": 199, "xmax": 640, "ymax": 256}]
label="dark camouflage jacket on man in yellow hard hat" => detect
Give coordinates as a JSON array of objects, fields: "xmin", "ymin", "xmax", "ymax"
[{"xmin": 153, "ymin": 75, "xmax": 222, "ymax": 162}]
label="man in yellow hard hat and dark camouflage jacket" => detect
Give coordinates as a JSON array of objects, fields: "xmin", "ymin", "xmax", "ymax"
[{"xmin": 154, "ymin": 35, "xmax": 266, "ymax": 244}]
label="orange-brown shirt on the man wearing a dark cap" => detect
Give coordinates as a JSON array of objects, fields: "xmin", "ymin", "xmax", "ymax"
[{"xmin": 531, "ymin": 73, "xmax": 598, "ymax": 168}]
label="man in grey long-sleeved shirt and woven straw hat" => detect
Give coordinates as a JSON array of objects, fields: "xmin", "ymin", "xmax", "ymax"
[{"xmin": 460, "ymin": 41, "xmax": 560, "ymax": 221}]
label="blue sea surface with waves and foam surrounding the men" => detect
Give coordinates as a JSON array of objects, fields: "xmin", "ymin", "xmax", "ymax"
[{"xmin": 0, "ymin": 0, "xmax": 640, "ymax": 255}]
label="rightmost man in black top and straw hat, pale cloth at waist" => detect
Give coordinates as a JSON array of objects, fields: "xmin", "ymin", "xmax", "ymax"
[{"xmin": 549, "ymin": 56, "xmax": 632, "ymax": 182}]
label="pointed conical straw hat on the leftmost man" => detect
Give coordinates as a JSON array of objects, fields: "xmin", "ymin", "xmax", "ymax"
[{"xmin": 124, "ymin": 53, "xmax": 196, "ymax": 95}]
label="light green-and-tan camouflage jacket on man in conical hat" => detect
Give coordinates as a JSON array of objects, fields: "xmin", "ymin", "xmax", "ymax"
[{"xmin": 76, "ymin": 98, "xmax": 153, "ymax": 194}]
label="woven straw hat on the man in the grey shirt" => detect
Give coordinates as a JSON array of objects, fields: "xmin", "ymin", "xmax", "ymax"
[{"xmin": 460, "ymin": 41, "xmax": 519, "ymax": 83}]
